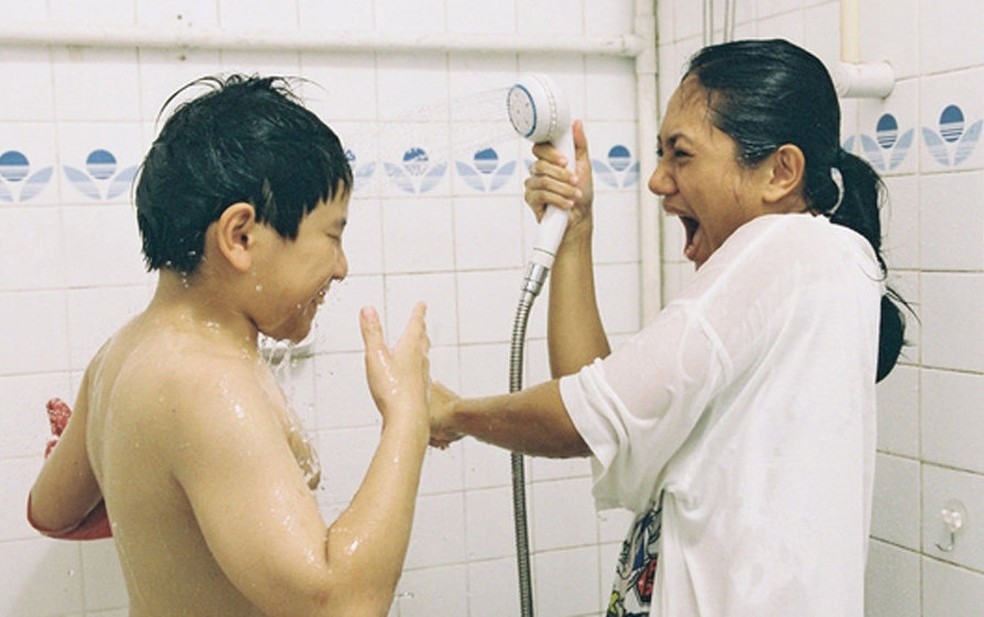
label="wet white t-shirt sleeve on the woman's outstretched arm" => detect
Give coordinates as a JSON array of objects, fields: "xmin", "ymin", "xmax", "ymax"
[{"xmin": 560, "ymin": 304, "xmax": 729, "ymax": 512}]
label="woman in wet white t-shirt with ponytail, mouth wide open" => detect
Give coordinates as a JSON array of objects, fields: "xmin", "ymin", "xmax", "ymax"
[{"xmin": 432, "ymin": 40, "xmax": 903, "ymax": 617}]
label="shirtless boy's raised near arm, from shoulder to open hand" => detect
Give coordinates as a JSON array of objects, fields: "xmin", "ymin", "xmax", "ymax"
[{"xmin": 168, "ymin": 309, "xmax": 428, "ymax": 617}]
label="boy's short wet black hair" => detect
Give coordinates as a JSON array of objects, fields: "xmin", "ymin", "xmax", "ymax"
[{"xmin": 135, "ymin": 75, "xmax": 352, "ymax": 274}]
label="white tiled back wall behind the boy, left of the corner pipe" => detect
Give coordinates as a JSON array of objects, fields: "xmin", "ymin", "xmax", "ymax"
[{"xmin": 0, "ymin": 0, "xmax": 640, "ymax": 617}]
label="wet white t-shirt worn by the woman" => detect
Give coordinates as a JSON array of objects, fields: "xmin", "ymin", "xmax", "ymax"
[{"xmin": 560, "ymin": 214, "xmax": 882, "ymax": 617}]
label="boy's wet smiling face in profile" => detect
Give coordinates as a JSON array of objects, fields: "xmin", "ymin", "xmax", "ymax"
[{"xmin": 252, "ymin": 193, "xmax": 349, "ymax": 343}]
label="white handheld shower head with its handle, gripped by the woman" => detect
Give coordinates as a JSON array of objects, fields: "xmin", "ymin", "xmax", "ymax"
[{"xmin": 506, "ymin": 73, "xmax": 574, "ymax": 295}]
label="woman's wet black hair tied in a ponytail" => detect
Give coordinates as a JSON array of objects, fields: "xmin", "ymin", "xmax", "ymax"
[{"xmin": 684, "ymin": 39, "xmax": 908, "ymax": 381}]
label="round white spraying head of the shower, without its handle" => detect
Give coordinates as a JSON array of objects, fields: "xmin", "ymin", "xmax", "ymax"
[{"xmin": 506, "ymin": 73, "xmax": 569, "ymax": 143}]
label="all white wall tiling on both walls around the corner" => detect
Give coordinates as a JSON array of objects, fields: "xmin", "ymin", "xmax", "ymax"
[{"xmin": 0, "ymin": 0, "xmax": 984, "ymax": 617}]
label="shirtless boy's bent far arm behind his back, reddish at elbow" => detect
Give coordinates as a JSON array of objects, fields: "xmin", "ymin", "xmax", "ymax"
[{"xmin": 27, "ymin": 373, "xmax": 111, "ymax": 540}]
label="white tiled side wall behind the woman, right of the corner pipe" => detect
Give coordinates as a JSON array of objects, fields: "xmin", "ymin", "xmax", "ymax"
[{"xmin": 658, "ymin": 0, "xmax": 984, "ymax": 617}]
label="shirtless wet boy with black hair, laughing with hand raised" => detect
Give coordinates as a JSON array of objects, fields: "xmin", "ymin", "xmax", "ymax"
[{"xmin": 29, "ymin": 76, "xmax": 429, "ymax": 617}]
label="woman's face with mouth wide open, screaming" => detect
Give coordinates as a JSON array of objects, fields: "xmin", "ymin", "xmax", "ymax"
[{"xmin": 649, "ymin": 77, "xmax": 767, "ymax": 268}]
